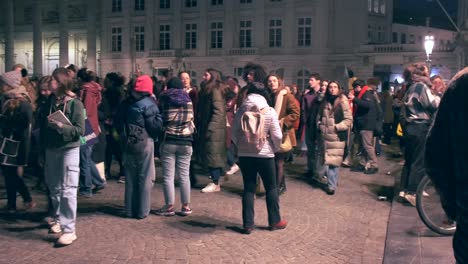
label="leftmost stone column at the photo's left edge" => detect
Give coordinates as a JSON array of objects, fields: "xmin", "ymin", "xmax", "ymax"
[{"xmin": 4, "ymin": 0, "xmax": 15, "ymax": 72}]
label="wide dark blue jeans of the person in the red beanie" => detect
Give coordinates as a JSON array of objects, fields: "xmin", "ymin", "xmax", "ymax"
[{"xmin": 123, "ymin": 139, "xmax": 156, "ymax": 219}]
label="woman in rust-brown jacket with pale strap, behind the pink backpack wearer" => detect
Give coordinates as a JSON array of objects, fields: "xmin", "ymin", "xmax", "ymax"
[{"xmin": 265, "ymin": 74, "xmax": 300, "ymax": 195}]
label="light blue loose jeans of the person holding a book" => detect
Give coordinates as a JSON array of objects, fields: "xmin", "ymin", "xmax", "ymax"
[{"xmin": 45, "ymin": 147, "xmax": 80, "ymax": 233}]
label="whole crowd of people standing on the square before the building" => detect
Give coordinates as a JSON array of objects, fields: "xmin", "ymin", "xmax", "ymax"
[{"xmin": 0, "ymin": 60, "xmax": 460, "ymax": 258}]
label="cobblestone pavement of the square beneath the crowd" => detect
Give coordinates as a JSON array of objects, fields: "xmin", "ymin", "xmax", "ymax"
[{"xmin": 0, "ymin": 153, "xmax": 398, "ymax": 264}]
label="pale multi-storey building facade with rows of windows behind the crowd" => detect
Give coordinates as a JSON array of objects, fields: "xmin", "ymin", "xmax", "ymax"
[{"xmin": 0, "ymin": 0, "xmax": 460, "ymax": 87}]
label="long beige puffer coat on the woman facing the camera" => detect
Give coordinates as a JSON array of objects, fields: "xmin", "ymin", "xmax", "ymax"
[{"xmin": 317, "ymin": 95, "xmax": 353, "ymax": 167}]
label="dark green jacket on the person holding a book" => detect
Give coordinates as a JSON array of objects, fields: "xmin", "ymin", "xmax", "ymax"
[{"xmin": 40, "ymin": 95, "xmax": 85, "ymax": 149}]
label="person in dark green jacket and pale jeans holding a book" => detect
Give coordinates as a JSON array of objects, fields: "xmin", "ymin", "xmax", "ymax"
[{"xmin": 40, "ymin": 68, "xmax": 85, "ymax": 246}]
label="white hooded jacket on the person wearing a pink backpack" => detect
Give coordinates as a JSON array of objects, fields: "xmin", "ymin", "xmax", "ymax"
[{"xmin": 232, "ymin": 93, "xmax": 283, "ymax": 158}]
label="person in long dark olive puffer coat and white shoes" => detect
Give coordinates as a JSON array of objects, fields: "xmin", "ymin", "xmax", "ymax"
[{"xmin": 196, "ymin": 69, "xmax": 227, "ymax": 193}]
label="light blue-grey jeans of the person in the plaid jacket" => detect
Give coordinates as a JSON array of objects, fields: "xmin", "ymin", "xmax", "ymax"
[{"xmin": 161, "ymin": 143, "xmax": 192, "ymax": 205}]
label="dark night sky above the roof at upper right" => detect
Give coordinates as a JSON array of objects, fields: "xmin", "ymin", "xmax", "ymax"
[{"xmin": 393, "ymin": 0, "xmax": 458, "ymax": 30}]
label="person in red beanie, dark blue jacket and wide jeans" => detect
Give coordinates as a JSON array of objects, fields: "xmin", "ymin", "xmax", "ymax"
[{"xmin": 114, "ymin": 75, "xmax": 162, "ymax": 219}]
